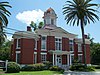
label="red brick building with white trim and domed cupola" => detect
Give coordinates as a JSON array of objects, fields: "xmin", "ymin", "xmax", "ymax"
[{"xmin": 11, "ymin": 8, "xmax": 90, "ymax": 66}]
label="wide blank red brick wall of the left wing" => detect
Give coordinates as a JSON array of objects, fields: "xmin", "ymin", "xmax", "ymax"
[{"xmin": 20, "ymin": 38, "xmax": 34, "ymax": 64}]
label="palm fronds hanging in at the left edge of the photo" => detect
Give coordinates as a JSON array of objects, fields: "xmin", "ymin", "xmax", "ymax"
[{"xmin": 0, "ymin": 2, "xmax": 11, "ymax": 46}]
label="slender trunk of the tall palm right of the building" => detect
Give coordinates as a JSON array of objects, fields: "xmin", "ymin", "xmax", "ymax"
[{"xmin": 81, "ymin": 19, "xmax": 87, "ymax": 67}]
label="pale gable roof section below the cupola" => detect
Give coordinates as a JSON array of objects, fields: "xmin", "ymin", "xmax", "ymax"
[{"xmin": 35, "ymin": 27, "xmax": 77, "ymax": 38}]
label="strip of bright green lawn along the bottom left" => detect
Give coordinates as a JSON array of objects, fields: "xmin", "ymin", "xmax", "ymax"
[{"xmin": 0, "ymin": 70, "xmax": 61, "ymax": 75}]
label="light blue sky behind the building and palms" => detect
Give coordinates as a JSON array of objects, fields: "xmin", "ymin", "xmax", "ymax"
[{"xmin": 1, "ymin": 0, "xmax": 100, "ymax": 42}]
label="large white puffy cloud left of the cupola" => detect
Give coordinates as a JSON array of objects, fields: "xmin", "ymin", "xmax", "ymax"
[{"xmin": 16, "ymin": 9, "xmax": 44, "ymax": 25}]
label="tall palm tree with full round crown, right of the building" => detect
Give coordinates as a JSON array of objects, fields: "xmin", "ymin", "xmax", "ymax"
[{"xmin": 63, "ymin": 0, "xmax": 99, "ymax": 66}]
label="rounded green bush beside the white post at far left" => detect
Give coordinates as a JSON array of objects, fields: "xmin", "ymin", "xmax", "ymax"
[{"xmin": 7, "ymin": 62, "xmax": 20, "ymax": 73}]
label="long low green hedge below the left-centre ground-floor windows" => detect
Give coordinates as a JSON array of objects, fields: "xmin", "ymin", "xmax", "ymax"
[{"xmin": 21, "ymin": 63, "xmax": 45, "ymax": 71}]
